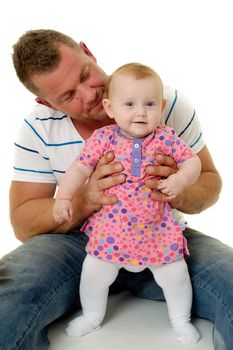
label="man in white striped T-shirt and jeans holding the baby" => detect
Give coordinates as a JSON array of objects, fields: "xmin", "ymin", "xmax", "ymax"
[{"xmin": 0, "ymin": 30, "xmax": 233, "ymax": 350}]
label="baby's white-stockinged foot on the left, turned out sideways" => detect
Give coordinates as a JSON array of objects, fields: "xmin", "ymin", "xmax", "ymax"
[{"xmin": 66, "ymin": 316, "xmax": 100, "ymax": 337}]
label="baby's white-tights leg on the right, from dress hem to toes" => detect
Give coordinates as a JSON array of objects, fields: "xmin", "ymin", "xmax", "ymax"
[{"xmin": 150, "ymin": 259, "xmax": 200, "ymax": 344}]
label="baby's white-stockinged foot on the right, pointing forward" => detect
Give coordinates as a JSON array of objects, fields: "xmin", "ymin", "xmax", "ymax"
[{"xmin": 173, "ymin": 322, "xmax": 201, "ymax": 345}]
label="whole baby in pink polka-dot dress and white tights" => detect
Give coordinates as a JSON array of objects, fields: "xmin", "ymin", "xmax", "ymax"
[{"xmin": 54, "ymin": 63, "xmax": 201, "ymax": 344}]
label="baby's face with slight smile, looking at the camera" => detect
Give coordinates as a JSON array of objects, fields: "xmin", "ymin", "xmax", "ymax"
[{"xmin": 106, "ymin": 75, "xmax": 163, "ymax": 138}]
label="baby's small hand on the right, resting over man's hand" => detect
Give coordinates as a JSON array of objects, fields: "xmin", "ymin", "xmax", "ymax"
[{"xmin": 158, "ymin": 173, "xmax": 187, "ymax": 199}]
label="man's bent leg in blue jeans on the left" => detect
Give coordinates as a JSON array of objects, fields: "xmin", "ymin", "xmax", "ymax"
[{"xmin": 0, "ymin": 232, "xmax": 87, "ymax": 350}]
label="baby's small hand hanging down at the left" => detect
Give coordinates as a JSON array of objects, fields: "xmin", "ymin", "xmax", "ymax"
[{"xmin": 53, "ymin": 199, "xmax": 73, "ymax": 224}]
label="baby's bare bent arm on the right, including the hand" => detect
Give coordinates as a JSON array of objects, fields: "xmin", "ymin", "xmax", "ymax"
[{"xmin": 158, "ymin": 155, "xmax": 201, "ymax": 199}]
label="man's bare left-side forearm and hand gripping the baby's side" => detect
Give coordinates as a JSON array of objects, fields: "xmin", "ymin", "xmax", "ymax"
[{"xmin": 10, "ymin": 153, "xmax": 125, "ymax": 241}]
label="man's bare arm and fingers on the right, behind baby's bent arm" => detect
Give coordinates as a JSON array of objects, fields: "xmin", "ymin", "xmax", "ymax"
[{"xmin": 146, "ymin": 146, "xmax": 222, "ymax": 214}]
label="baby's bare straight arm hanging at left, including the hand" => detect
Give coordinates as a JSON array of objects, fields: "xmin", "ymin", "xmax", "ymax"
[{"xmin": 53, "ymin": 160, "xmax": 93, "ymax": 224}]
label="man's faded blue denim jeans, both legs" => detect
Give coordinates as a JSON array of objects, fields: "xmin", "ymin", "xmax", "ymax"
[{"xmin": 0, "ymin": 229, "xmax": 233, "ymax": 350}]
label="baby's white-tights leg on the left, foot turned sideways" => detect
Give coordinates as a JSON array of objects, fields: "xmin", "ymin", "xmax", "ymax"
[{"xmin": 66, "ymin": 254, "xmax": 119, "ymax": 337}]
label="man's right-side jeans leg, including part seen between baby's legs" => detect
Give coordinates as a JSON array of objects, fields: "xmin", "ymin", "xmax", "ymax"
[{"xmin": 124, "ymin": 229, "xmax": 233, "ymax": 350}]
